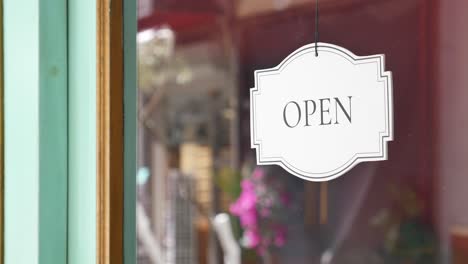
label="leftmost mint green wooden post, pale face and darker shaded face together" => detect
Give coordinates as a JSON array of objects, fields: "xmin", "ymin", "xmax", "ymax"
[{"xmin": 4, "ymin": 0, "xmax": 67, "ymax": 264}]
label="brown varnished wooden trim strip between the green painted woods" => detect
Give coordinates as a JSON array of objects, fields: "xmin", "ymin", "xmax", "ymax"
[{"xmin": 96, "ymin": 0, "xmax": 124, "ymax": 264}]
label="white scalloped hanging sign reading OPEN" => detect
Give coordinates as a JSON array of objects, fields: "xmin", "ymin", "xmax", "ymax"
[{"xmin": 250, "ymin": 43, "xmax": 393, "ymax": 181}]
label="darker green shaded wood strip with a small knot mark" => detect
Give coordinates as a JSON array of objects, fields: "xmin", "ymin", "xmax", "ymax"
[{"xmin": 38, "ymin": 0, "xmax": 68, "ymax": 264}]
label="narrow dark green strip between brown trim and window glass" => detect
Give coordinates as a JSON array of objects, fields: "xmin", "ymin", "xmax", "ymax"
[{"xmin": 123, "ymin": 1, "xmax": 137, "ymax": 264}]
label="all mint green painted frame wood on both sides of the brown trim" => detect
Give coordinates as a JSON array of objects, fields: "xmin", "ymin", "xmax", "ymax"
[{"xmin": 3, "ymin": 0, "xmax": 136, "ymax": 264}]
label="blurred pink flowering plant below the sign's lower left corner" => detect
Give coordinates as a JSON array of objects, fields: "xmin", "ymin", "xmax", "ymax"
[{"xmin": 230, "ymin": 167, "xmax": 292, "ymax": 256}]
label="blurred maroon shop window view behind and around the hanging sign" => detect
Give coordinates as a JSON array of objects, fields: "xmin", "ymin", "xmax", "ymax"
[{"xmin": 133, "ymin": 0, "xmax": 468, "ymax": 264}]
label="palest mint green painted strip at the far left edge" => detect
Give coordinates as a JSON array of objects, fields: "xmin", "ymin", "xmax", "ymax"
[{"xmin": 3, "ymin": 0, "xmax": 39, "ymax": 264}]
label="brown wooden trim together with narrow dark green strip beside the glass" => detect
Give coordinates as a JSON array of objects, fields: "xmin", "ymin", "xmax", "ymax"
[{"xmin": 96, "ymin": 0, "xmax": 137, "ymax": 264}]
